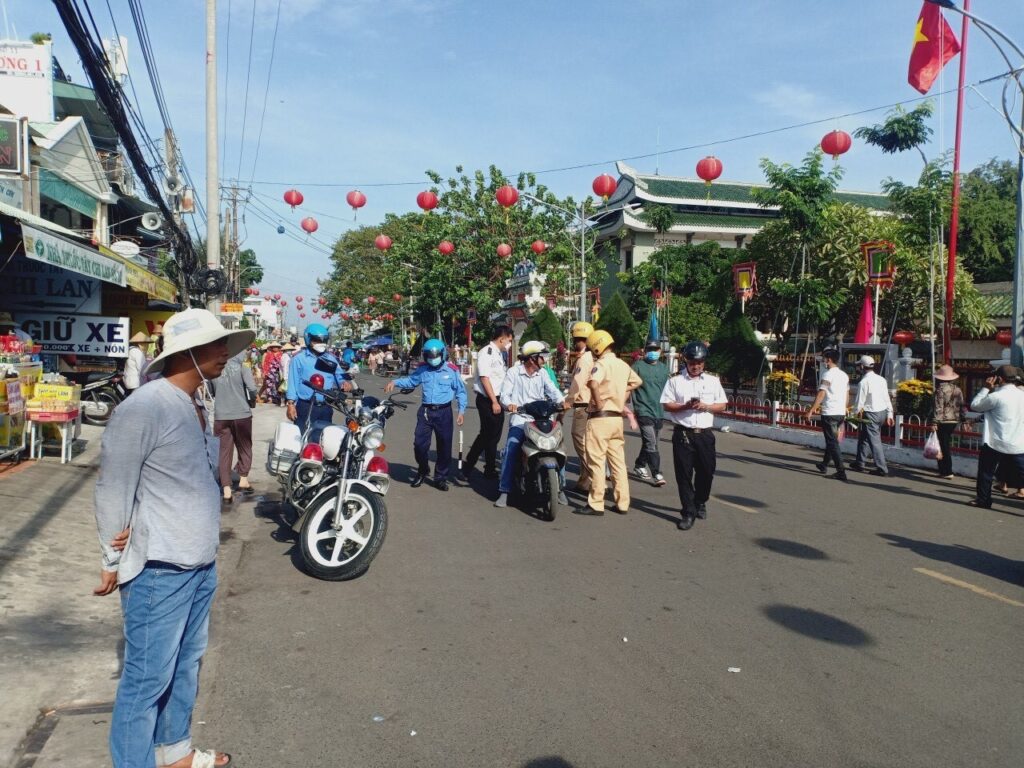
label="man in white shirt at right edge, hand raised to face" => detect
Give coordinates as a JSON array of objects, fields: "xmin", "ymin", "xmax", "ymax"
[{"xmin": 968, "ymin": 366, "xmax": 1024, "ymax": 509}]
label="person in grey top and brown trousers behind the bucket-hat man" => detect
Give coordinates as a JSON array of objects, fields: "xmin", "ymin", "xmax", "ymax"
[{"xmin": 211, "ymin": 352, "xmax": 256, "ymax": 503}]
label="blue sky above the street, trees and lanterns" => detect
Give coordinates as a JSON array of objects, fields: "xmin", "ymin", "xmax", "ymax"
[{"xmin": 6, "ymin": 0, "xmax": 1024, "ymax": 319}]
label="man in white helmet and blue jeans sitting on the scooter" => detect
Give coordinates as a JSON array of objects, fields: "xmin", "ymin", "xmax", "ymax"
[{"xmin": 495, "ymin": 341, "xmax": 568, "ymax": 507}]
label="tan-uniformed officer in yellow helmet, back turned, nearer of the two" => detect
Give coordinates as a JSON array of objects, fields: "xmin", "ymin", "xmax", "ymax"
[{"xmin": 572, "ymin": 331, "xmax": 643, "ymax": 515}]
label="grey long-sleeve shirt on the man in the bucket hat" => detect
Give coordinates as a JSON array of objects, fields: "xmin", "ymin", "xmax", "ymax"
[{"xmin": 94, "ymin": 379, "xmax": 220, "ymax": 584}]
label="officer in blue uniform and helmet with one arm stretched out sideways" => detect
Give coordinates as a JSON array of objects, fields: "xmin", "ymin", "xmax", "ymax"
[{"xmin": 384, "ymin": 339, "xmax": 467, "ymax": 490}]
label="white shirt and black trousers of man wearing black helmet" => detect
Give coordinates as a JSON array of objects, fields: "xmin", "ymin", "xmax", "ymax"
[{"xmin": 662, "ymin": 366, "xmax": 729, "ymax": 522}]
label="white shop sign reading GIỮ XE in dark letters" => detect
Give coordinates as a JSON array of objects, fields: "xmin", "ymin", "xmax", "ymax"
[{"xmin": 14, "ymin": 312, "xmax": 131, "ymax": 357}]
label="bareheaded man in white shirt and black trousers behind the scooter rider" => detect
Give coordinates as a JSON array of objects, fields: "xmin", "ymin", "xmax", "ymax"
[{"xmin": 459, "ymin": 326, "xmax": 513, "ymax": 482}]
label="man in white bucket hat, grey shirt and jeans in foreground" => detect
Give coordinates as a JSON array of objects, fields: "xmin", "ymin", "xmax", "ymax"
[{"xmin": 94, "ymin": 309, "xmax": 254, "ymax": 768}]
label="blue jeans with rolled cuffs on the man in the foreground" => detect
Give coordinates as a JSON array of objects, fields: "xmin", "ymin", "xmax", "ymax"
[{"xmin": 111, "ymin": 561, "xmax": 217, "ymax": 768}]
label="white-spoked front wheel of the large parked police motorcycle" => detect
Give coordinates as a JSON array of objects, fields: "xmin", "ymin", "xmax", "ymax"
[{"xmin": 299, "ymin": 485, "xmax": 387, "ymax": 582}]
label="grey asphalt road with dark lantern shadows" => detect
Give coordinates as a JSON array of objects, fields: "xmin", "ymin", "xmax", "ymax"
[{"xmin": 197, "ymin": 382, "xmax": 1024, "ymax": 768}]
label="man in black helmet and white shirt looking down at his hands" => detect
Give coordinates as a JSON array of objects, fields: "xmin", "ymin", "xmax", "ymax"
[{"xmin": 662, "ymin": 341, "xmax": 728, "ymax": 530}]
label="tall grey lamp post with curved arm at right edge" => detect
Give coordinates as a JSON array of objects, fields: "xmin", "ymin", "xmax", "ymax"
[{"xmin": 928, "ymin": 0, "xmax": 1024, "ymax": 368}]
